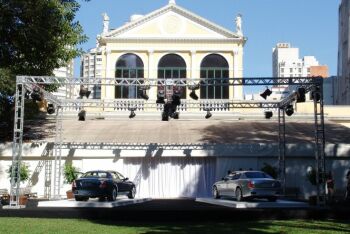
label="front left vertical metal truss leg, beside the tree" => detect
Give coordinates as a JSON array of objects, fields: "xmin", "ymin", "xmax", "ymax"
[{"xmin": 10, "ymin": 82, "xmax": 25, "ymax": 207}]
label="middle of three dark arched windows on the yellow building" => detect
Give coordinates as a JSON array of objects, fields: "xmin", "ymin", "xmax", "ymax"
[{"xmin": 158, "ymin": 54, "xmax": 187, "ymax": 99}]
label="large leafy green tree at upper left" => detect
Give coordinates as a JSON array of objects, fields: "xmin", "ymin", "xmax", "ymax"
[{"xmin": 0, "ymin": 0, "xmax": 88, "ymax": 132}]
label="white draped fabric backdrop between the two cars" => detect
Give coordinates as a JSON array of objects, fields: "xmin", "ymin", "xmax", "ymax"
[{"xmin": 83, "ymin": 158, "xmax": 216, "ymax": 198}]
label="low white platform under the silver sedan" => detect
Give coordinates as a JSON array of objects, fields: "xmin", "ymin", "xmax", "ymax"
[{"xmin": 196, "ymin": 198, "xmax": 310, "ymax": 209}]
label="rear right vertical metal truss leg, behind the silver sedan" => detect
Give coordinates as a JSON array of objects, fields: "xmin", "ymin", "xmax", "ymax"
[{"xmin": 278, "ymin": 108, "xmax": 286, "ymax": 194}]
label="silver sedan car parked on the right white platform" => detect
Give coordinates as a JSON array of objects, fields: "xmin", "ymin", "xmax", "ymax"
[{"xmin": 213, "ymin": 171, "xmax": 281, "ymax": 201}]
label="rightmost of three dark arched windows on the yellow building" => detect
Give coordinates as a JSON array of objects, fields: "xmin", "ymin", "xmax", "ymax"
[{"xmin": 201, "ymin": 54, "xmax": 229, "ymax": 99}]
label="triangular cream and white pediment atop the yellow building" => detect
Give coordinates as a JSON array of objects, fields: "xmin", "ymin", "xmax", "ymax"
[{"xmin": 102, "ymin": 4, "xmax": 244, "ymax": 40}]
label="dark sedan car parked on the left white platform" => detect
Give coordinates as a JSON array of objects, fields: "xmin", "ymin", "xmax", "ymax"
[{"xmin": 72, "ymin": 171, "xmax": 136, "ymax": 201}]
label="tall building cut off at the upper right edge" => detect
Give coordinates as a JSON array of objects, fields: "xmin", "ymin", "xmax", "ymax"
[{"xmin": 335, "ymin": 0, "xmax": 350, "ymax": 105}]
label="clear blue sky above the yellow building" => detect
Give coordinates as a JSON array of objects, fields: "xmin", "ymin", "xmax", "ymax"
[{"xmin": 75, "ymin": 0, "xmax": 340, "ymax": 77}]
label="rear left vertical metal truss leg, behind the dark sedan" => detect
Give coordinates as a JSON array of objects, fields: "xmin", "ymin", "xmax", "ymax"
[{"xmin": 52, "ymin": 107, "xmax": 62, "ymax": 199}]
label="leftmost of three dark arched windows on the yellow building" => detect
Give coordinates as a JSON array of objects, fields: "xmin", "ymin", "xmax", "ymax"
[{"xmin": 115, "ymin": 54, "xmax": 144, "ymax": 99}]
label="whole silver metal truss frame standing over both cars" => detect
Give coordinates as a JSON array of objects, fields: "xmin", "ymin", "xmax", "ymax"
[{"xmin": 10, "ymin": 76, "xmax": 326, "ymax": 207}]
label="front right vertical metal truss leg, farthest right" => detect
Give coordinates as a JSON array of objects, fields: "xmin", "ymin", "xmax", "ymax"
[{"xmin": 313, "ymin": 85, "xmax": 326, "ymax": 205}]
